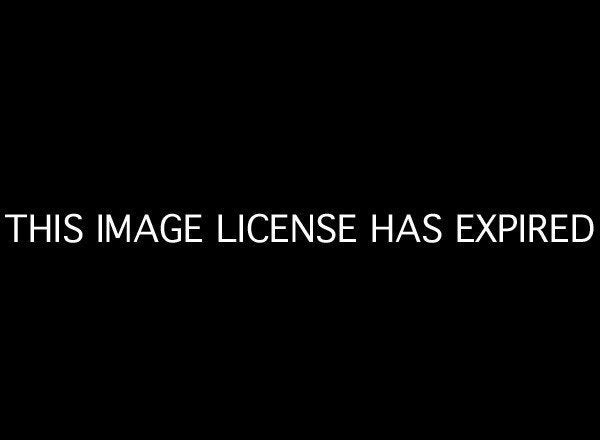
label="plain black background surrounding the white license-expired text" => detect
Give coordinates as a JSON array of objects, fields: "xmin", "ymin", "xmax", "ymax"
[{"xmin": 1, "ymin": 5, "xmax": 598, "ymax": 433}]
